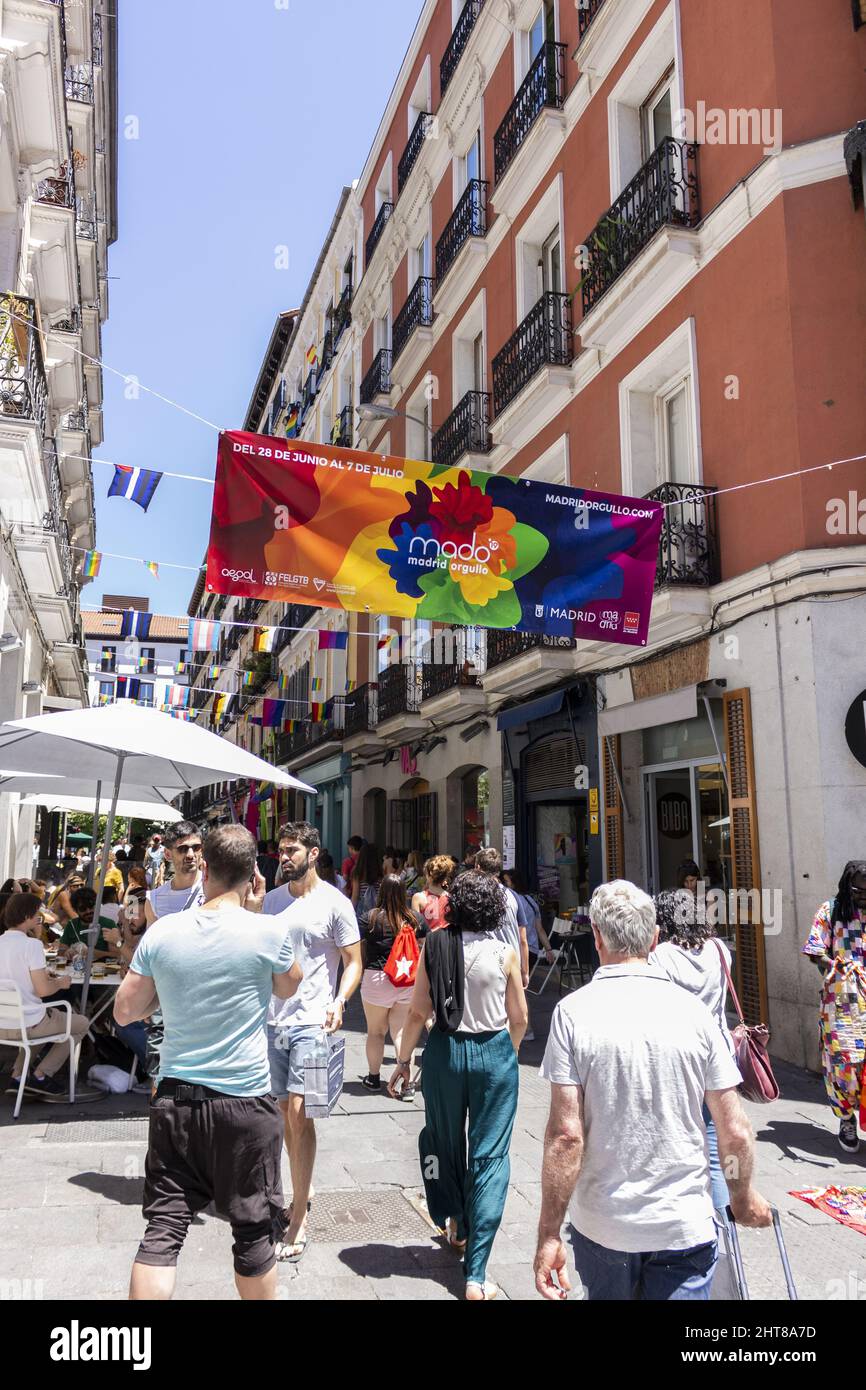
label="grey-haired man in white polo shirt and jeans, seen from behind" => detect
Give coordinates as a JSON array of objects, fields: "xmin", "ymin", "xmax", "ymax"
[{"xmin": 535, "ymin": 880, "xmax": 771, "ymax": 1301}]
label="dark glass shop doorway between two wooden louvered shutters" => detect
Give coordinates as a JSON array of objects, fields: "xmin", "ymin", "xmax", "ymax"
[{"xmin": 642, "ymin": 759, "xmax": 733, "ymax": 894}]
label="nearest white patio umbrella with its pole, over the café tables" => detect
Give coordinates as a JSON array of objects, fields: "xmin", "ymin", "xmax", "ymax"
[{"xmin": 0, "ymin": 701, "xmax": 314, "ymax": 1008}]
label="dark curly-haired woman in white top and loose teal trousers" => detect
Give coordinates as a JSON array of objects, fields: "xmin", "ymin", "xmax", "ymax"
[{"xmin": 388, "ymin": 870, "xmax": 528, "ymax": 1302}]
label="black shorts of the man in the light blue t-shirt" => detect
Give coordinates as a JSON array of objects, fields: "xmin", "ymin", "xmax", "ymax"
[{"xmin": 135, "ymin": 1095, "xmax": 285, "ymax": 1279}]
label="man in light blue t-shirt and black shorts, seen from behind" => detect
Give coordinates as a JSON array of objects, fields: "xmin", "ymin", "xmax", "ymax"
[{"xmin": 114, "ymin": 826, "xmax": 302, "ymax": 1300}]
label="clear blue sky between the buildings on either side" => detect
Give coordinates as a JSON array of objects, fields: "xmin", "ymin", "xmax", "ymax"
[{"xmin": 89, "ymin": 0, "xmax": 421, "ymax": 613}]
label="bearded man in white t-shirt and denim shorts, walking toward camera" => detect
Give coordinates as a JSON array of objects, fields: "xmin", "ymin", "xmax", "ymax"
[{"xmin": 263, "ymin": 820, "xmax": 363, "ymax": 1264}]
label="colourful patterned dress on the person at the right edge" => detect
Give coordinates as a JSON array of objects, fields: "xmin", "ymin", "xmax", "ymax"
[{"xmin": 803, "ymin": 899, "xmax": 866, "ymax": 1120}]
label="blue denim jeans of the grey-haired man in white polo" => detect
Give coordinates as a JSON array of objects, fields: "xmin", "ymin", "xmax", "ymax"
[{"xmin": 570, "ymin": 1226, "xmax": 719, "ymax": 1302}]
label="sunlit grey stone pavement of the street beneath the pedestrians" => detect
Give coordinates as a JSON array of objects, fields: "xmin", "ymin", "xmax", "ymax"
[{"xmin": 0, "ymin": 987, "xmax": 866, "ymax": 1301}]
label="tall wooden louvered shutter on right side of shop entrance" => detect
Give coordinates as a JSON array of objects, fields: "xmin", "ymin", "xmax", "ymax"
[{"xmin": 724, "ymin": 689, "xmax": 769, "ymax": 1023}]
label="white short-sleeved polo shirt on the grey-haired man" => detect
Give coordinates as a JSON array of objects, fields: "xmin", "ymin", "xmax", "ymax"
[{"xmin": 541, "ymin": 963, "xmax": 741, "ymax": 1252}]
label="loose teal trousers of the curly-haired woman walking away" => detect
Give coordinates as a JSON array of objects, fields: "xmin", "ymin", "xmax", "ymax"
[{"xmin": 418, "ymin": 1029, "xmax": 517, "ymax": 1283}]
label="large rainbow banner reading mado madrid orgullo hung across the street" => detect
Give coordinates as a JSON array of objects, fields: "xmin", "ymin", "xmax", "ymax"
[{"xmin": 207, "ymin": 431, "xmax": 663, "ymax": 646}]
